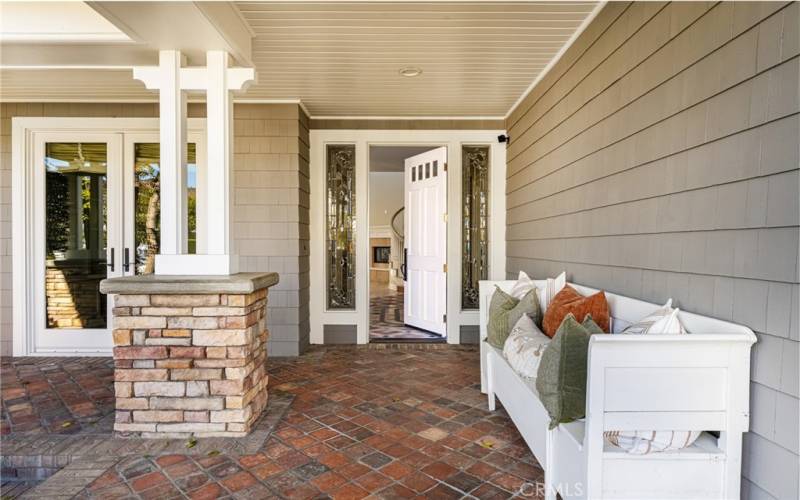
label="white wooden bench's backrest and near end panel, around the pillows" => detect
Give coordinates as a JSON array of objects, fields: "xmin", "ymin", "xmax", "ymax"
[{"xmin": 480, "ymin": 280, "xmax": 756, "ymax": 432}]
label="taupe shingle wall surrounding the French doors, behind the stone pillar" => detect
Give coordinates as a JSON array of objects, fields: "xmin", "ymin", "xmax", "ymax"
[{"xmin": 0, "ymin": 103, "xmax": 309, "ymax": 356}]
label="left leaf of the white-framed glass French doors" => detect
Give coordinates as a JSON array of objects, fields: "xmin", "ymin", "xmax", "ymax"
[{"xmin": 29, "ymin": 132, "xmax": 124, "ymax": 354}]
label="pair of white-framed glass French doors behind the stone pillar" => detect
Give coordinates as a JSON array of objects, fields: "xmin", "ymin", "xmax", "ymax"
[{"xmin": 26, "ymin": 131, "xmax": 204, "ymax": 355}]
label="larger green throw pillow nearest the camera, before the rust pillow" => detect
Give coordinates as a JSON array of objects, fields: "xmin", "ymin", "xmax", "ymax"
[{"xmin": 536, "ymin": 313, "xmax": 603, "ymax": 429}]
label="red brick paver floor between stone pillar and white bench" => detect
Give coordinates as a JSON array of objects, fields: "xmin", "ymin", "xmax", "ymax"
[{"xmin": 3, "ymin": 346, "xmax": 542, "ymax": 499}]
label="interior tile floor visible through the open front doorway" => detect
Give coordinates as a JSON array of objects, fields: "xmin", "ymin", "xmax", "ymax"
[{"xmin": 369, "ymin": 282, "xmax": 444, "ymax": 342}]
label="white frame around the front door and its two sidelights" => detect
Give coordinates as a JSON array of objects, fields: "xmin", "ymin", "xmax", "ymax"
[{"xmin": 309, "ymin": 130, "xmax": 506, "ymax": 344}]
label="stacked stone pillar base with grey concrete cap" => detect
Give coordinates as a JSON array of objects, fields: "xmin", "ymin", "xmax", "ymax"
[{"xmin": 100, "ymin": 273, "xmax": 278, "ymax": 438}]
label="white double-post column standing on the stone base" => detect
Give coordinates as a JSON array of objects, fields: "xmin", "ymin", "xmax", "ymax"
[{"xmin": 134, "ymin": 50, "xmax": 255, "ymax": 275}]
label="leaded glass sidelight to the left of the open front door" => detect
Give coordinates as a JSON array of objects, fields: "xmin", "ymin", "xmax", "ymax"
[{"xmin": 325, "ymin": 144, "xmax": 356, "ymax": 309}]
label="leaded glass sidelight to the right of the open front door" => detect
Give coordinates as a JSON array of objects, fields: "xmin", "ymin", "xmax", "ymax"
[{"xmin": 461, "ymin": 146, "xmax": 489, "ymax": 309}]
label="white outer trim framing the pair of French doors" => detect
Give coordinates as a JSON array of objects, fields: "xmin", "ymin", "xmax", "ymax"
[{"xmin": 11, "ymin": 117, "xmax": 206, "ymax": 356}]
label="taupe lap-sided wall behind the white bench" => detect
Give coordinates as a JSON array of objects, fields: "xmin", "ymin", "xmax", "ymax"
[{"xmin": 506, "ymin": 2, "xmax": 800, "ymax": 499}]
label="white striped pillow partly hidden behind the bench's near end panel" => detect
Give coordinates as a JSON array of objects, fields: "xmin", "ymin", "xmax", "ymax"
[{"xmin": 603, "ymin": 299, "xmax": 700, "ymax": 455}]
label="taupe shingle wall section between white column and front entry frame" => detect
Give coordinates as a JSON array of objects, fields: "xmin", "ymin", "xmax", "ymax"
[{"xmin": 233, "ymin": 104, "xmax": 309, "ymax": 356}]
